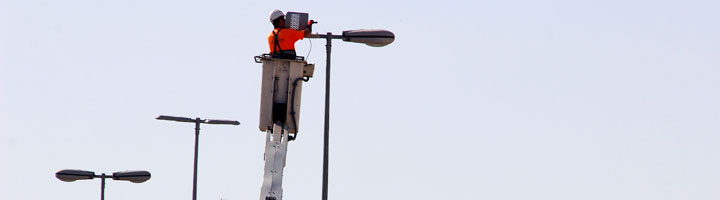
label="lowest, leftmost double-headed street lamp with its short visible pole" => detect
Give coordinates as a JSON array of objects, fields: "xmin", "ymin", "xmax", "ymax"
[{"xmin": 55, "ymin": 169, "xmax": 150, "ymax": 200}]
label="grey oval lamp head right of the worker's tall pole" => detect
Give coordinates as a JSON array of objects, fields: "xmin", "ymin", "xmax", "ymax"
[{"xmin": 342, "ymin": 29, "xmax": 395, "ymax": 47}]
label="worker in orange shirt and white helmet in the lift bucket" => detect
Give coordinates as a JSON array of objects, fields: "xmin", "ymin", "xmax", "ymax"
[{"xmin": 268, "ymin": 9, "xmax": 312, "ymax": 59}]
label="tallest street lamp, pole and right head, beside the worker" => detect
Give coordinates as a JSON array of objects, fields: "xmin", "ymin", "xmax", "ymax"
[{"xmin": 310, "ymin": 29, "xmax": 395, "ymax": 200}]
